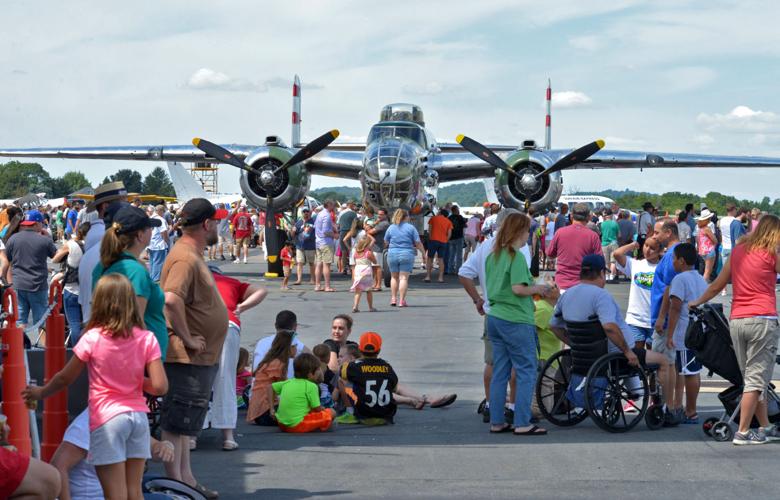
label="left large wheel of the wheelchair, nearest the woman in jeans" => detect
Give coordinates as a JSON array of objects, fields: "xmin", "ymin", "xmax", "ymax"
[{"xmin": 535, "ymin": 349, "xmax": 588, "ymax": 427}]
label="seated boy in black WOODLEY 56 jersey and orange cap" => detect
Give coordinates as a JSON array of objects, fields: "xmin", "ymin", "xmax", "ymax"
[{"xmin": 339, "ymin": 332, "xmax": 398, "ymax": 425}]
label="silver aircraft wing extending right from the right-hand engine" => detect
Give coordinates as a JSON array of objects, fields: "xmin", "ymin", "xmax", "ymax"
[{"xmin": 545, "ymin": 149, "xmax": 780, "ymax": 170}]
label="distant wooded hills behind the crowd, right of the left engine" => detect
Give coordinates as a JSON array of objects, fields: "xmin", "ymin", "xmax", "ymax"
[{"xmin": 310, "ymin": 182, "xmax": 780, "ymax": 215}]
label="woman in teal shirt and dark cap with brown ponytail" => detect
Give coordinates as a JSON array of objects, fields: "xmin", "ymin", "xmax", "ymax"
[{"xmin": 92, "ymin": 205, "xmax": 168, "ymax": 360}]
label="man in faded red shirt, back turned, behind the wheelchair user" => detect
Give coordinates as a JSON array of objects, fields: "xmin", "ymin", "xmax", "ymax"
[{"xmin": 547, "ymin": 203, "xmax": 603, "ymax": 292}]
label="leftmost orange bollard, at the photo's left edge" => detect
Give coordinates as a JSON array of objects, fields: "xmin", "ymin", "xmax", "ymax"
[{"xmin": 0, "ymin": 288, "xmax": 32, "ymax": 456}]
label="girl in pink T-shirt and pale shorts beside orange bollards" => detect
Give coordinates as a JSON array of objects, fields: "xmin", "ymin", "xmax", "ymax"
[{"xmin": 22, "ymin": 273, "xmax": 168, "ymax": 498}]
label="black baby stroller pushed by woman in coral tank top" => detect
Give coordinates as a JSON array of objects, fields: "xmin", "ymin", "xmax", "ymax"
[{"xmin": 685, "ymin": 304, "xmax": 780, "ymax": 441}]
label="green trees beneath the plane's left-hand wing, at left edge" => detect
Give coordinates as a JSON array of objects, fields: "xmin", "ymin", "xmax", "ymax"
[{"xmin": 0, "ymin": 161, "xmax": 176, "ymax": 198}]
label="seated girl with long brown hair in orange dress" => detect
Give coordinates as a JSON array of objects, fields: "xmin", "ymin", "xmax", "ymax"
[{"xmin": 246, "ymin": 329, "xmax": 297, "ymax": 426}]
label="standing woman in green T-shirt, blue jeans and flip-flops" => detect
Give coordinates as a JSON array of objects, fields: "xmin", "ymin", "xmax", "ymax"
[{"xmin": 485, "ymin": 214, "xmax": 551, "ymax": 435}]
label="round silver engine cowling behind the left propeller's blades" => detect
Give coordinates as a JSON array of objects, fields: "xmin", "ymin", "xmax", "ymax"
[{"xmin": 239, "ymin": 147, "xmax": 311, "ymax": 211}]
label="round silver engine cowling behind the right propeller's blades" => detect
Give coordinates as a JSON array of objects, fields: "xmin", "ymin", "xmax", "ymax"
[{"xmin": 495, "ymin": 150, "xmax": 563, "ymax": 212}]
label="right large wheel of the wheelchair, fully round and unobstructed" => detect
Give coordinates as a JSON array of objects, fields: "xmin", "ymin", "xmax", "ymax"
[{"xmin": 585, "ymin": 353, "xmax": 649, "ymax": 433}]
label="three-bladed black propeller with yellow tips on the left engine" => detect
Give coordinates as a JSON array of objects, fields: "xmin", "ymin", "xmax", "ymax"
[{"xmin": 192, "ymin": 129, "xmax": 339, "ymax": 276}]
